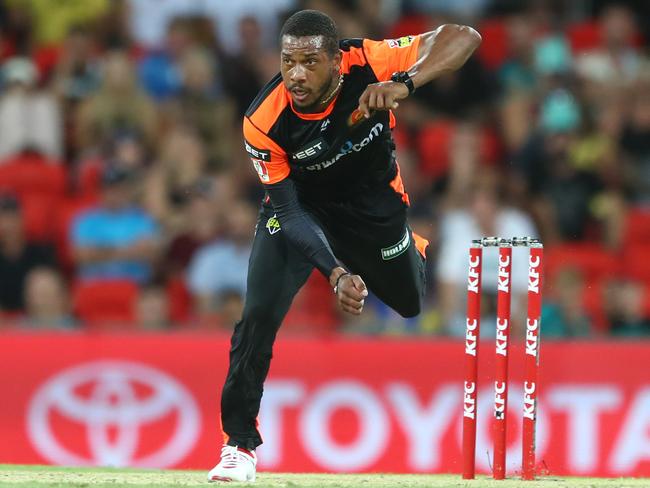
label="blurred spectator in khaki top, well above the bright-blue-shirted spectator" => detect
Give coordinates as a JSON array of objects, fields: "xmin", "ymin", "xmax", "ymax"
[{"xmin": 75, "ymin": 51, "xmax": 157, "ymax": 150}]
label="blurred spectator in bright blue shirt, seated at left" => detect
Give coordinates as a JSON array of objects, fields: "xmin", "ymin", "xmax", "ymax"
[{"xmin": 71, "ymin": 167, "xmax": 159, "ymax": 284}]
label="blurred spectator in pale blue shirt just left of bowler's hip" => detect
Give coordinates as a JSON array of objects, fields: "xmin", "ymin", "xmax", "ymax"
[{"xmin": 187, "ymin": 202, "xmax": 254, "ymax": 313}]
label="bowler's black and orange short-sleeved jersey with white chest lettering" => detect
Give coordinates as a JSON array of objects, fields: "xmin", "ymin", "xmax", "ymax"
[{"xmin": 244, "ymin": 36, "xmax": 419, "ymax": 199}]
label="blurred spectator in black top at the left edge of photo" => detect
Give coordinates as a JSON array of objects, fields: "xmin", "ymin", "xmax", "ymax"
[{"xmin": 0, "ymin": 194, "xmax": 55, "ymax": 314}]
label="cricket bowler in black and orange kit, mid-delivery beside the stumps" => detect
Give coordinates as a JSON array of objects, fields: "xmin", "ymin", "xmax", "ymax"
[{"xmin": 208, "ymin": 10, "xmax": 481, "ymax": 481}]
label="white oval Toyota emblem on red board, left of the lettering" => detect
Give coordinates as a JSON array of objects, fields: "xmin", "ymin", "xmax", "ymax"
[{"xmin": 27, "ymin": 361, "xmax": 201, "ymax": 468}]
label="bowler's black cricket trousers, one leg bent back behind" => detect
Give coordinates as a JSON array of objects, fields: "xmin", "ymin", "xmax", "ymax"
[{"xmin": 221, "ymin": 185, "xmax": 425, "ymax": 449}]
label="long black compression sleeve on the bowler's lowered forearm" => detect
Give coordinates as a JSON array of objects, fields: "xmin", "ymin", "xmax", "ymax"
[{"xmin": 264, "ymin": 178, "xmax": 338, "ymax": 279}]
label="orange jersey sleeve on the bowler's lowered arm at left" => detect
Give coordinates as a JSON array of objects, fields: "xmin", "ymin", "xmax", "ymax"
[{"xmin": 244, "ymin": 117, "xmax": 290, "ymax": 185}]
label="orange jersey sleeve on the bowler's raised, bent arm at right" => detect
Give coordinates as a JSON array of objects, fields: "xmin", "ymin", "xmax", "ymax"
[{"xmin": 363, "ymin": 36, "xmax": 420, "ymax": 81}]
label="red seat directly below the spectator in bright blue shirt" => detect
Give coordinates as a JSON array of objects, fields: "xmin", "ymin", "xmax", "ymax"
[{"xmin": 73, "ymin": 280, "xmax": 138, "ymax": 328}]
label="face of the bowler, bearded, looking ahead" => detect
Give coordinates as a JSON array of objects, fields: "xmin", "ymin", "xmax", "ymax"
[{"xmin": 280, "ymin": 36, "xmax": 341, "ymax": 111}]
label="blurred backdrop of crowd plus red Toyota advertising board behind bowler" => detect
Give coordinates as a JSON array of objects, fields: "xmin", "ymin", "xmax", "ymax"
[{"xmin": 0, "ymin": 0, "xmax": 650, "ymax": 477}]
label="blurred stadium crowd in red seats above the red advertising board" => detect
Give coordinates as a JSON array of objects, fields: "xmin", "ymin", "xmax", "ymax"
[{"xmin": 0, "ymin": 0, "xmax": 650, "ymax": 337}]
